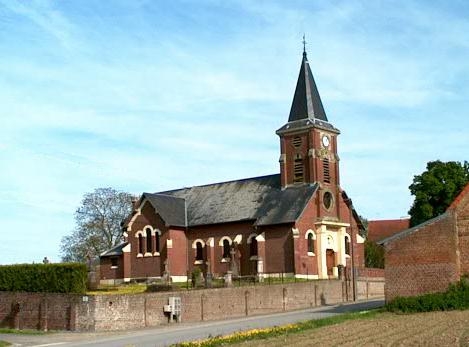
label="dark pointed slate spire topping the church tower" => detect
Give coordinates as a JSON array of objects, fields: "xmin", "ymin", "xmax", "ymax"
[{"xmin": 288, "ymin": 45, "xmax": 328, "ymax": 122}]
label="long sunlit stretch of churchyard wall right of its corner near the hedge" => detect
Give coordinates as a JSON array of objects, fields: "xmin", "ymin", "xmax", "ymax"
[{"xmin": 87, "ymin": 280, "xmax": 346, "ymax": 331}]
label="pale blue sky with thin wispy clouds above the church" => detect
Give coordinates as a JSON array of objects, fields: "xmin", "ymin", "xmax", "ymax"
[{"xmin": 0, "ymin": 0, "xmax": 469, "ymax": 264}]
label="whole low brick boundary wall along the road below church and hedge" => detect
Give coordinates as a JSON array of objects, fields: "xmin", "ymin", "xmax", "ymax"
[{"xmin": 0, "ymin": 280, "xmax": 384, "ymax": 331}]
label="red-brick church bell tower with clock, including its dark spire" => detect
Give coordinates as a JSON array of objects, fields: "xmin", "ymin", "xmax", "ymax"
[{"xmin": 276, "ymin": 50, "xmax": 340, "ymax": 188}]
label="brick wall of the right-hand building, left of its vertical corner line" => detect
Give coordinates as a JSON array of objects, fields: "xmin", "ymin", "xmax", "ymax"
[{"xmin": 385, "ymin": 215, "xmax": 459, "ymax": 300}]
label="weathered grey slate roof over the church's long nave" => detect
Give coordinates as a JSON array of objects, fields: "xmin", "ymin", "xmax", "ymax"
[{"xmin": 144, "ymin": 174, "xmax": 318, "ymax": 227}]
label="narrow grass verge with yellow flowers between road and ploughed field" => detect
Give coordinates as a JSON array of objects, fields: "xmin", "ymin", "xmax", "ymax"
[{"xmin": 171, "ymin": 309, "xmax": 381, "ymax": 347}]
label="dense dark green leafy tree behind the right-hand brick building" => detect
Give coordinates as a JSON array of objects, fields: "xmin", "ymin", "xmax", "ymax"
[{"xmin": 409, "ymin": 160, "xmax": 469, "ymax": 226}]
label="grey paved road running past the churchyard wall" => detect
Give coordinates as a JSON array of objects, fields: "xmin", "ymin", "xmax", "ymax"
[{"xmin": 0, "ymin": 300, "xmax": 384, "ymax": 347}]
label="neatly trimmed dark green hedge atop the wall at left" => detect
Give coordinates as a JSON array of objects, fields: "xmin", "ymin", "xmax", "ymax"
[{"xmin": 0, "ymin": 263, "xmax": 87, "ymax": 294}]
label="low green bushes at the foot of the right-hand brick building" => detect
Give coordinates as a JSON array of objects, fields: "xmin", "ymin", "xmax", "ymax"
[{"xmin": 386, "ymin": 278, "xmax": 469, "ymax": 313}]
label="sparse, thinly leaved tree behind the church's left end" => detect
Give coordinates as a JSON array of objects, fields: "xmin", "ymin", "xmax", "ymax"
[{"xmin": 61, "ymin": 188, "xmax": 132, "ymax": 262}]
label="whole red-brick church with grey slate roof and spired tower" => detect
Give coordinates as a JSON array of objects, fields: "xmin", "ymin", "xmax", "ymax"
[{"xmin": 100, "ymin": 47, "xmax": 364, "ymax": 284}]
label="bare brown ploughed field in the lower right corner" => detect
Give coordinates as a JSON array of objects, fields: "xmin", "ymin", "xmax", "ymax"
[{"xmin": 233, "ymin": 310, "xmax": 469, "ymax": 347}]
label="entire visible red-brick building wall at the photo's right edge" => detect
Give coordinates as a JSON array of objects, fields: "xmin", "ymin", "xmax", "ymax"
[{"xmin": 385, "ymin": 185, "xmax": 469, "ymax": 300}]
